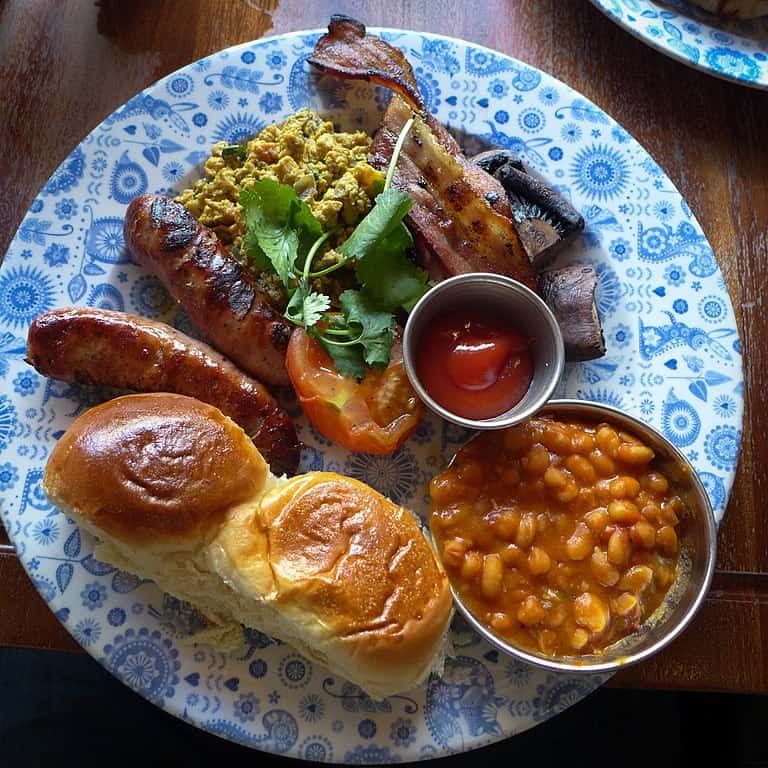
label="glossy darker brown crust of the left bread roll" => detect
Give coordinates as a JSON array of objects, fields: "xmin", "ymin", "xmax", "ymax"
[{"xmin": 44, "ymin": 394, "xmax": 269, "ymax": 549}]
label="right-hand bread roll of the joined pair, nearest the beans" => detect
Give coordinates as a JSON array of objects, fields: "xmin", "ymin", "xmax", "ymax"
[{"xmin": 216, "ymin": 472, "xmax": 452, "ymax": 695}]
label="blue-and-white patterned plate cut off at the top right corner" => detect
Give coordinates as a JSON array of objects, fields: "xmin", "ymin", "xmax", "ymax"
[{"xmin": 592, "ymin": 0, "xmax": 768, "ymax": 89}]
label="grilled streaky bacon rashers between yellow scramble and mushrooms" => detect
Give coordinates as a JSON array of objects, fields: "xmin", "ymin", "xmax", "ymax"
[{"xmin": 308, "ymin": 16, "xmax": 536, "ymax": 290}]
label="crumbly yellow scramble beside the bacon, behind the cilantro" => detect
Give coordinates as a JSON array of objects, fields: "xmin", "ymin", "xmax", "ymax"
[{"xmin": 177, "ymin": 109, "xmax": 384, "ymax": 250}]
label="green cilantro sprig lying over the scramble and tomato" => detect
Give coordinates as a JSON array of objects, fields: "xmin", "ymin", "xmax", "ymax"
[{"xmin": 240, "ymin": 118, "xmax": 428, "ymax": 378}]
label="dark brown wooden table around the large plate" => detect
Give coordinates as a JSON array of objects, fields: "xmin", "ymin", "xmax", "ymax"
[{"xmin": 0, "ymin": 0, "xmax": 768, "ymax": 692}]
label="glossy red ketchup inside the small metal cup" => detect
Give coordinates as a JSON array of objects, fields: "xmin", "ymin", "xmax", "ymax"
[{"xmin": 416, "ymin": 309, "xmax": 533, "ymax": 419}]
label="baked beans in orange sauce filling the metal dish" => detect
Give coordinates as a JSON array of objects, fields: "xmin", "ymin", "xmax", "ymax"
[{"xmin": 430, "ymin": 417, "xmax": 687, "ymax": 656}]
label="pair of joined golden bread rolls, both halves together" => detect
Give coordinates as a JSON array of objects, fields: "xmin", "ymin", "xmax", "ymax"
[{"xmin": 43, "ymin": 394, "xmax": 452, "ymax": 697}]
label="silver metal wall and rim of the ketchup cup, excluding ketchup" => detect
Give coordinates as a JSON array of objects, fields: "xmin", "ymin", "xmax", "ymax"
[{"xmin": 403, "ymin": 272, "xmax": 565, "ymax": 429}]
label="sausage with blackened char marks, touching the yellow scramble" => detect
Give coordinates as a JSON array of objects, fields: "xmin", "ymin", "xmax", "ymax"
[{"xmin": 124, "ymin": 195, "xmax": 291, "ymax": 385}]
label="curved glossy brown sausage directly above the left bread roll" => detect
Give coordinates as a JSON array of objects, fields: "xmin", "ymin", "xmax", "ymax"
[{"xmin": 27, "ymin": 307, "xmax": 300, "ymax": 474}]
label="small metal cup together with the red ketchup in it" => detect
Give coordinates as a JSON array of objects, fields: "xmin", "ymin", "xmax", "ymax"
[{"xmin": 403, "ymin": 272, "xmax": 565, "ymax": 430}]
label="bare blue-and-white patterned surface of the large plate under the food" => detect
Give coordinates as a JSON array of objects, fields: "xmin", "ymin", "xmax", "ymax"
[{"xmin": 0, "ymin": 30, "xmax": 743, "ymax": 764}]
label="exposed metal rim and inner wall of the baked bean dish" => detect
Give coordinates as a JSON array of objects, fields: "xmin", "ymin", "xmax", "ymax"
[{"xmin": 436, "ymin": 400, "xmax": 717, "ymax": 673}]
